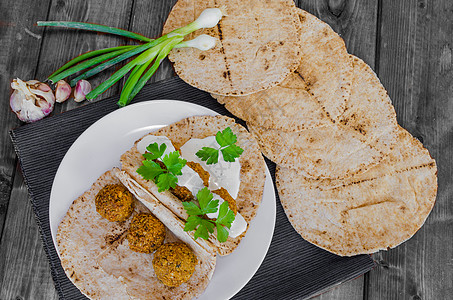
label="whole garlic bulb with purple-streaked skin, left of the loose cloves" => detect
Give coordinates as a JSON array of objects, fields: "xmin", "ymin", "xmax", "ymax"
[{"xmin": 9, "ymin": 78, "xmax": 55, "ymax": 123}]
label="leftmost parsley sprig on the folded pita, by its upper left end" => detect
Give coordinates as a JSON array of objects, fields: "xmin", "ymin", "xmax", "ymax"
[{"xmin": 137, "ymin": 143, "xmax": 187, "ymax": 192}]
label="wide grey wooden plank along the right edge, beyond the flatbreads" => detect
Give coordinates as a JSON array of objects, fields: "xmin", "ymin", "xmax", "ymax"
[{"xmin": 368, "ymin": 0, "xmax": 453, "ymax": 299}]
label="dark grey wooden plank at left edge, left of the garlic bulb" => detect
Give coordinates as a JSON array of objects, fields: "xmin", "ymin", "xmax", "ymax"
[{"xmin": 0, "ymin": 0, "xmax": 49, "ymax": 243}]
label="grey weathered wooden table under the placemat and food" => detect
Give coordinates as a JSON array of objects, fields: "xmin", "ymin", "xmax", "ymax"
[{"xmin": 0, "ymin": 0, "xmax": 453, "ymax": 300}]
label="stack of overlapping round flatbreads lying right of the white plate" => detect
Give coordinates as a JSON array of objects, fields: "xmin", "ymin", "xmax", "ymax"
[{"xmin": 164, "ymin": 0, "xmax": 437, "ymax": 256}]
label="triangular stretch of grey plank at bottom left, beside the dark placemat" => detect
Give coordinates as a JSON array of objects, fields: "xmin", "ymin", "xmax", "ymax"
[{"xmin": 0, "ymin": 171, "xmax": 58, "ymax": 300}]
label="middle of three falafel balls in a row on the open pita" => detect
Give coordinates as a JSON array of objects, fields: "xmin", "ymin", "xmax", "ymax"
[{"xmin": 127, "ymin": 213, "xmax": 165, "ymax": 253}]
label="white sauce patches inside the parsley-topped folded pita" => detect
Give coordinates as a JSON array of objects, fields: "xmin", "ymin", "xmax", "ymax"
[{"xmin": 137, "ymin": 135, "xmax": 247, "ymax": 238}]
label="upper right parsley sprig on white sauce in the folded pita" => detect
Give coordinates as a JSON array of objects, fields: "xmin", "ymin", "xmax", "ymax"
[{"xmin": 195, "ymin": 127, "xmax": 244, "ymax": 165}]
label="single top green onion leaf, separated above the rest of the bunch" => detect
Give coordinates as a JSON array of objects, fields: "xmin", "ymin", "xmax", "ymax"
[{"xmin": 38, "ymin": 21, "xmax": 152, "ymax": 42}]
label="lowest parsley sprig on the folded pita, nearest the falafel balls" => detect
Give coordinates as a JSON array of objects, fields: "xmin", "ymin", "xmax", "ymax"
[{"xmin": 183, "ymin": 187, "xmax": 235, "ymax": 243}]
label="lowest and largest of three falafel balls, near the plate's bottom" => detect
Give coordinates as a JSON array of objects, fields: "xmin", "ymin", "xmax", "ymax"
[{"xmin": 153, "ymin": 242, "xmax": 198, "ymax": 287}]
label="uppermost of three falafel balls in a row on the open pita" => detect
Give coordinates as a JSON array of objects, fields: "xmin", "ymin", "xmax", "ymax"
[{"xmin": 94, "ymin": 184, "xmax": 134, "ymax": 222}]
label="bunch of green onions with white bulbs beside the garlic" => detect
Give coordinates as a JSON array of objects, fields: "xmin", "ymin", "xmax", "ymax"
[{"xmin": 38, "ymin": 8, "xmax": 224, "ymax": 107}]
